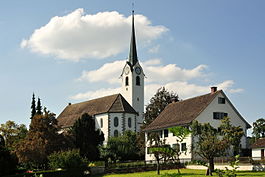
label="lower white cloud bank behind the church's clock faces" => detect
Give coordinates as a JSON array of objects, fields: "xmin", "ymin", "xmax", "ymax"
[{"xmin": 71, "ymin": 59, "xmax": 243, "ymax": 104}]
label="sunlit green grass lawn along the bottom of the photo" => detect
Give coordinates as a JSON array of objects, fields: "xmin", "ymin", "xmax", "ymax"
[{"xmin": 95, "ymin": 169, "xmax": 265, "ymax": 177}]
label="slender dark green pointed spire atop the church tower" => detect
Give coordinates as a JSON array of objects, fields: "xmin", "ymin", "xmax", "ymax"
[{"xmin": 129, "ymin": 10, "xmax": 138, "ymax": 66}]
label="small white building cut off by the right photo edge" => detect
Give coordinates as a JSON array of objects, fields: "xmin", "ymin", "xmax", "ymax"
[{"xmin": 251, "ymin": 138, "xmax": 265, "ymax": 160}]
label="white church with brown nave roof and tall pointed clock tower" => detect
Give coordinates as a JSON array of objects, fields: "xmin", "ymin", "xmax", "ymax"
[{"xmin": 57, "ymin": 11, "xmax": 145, "ymax": 142}]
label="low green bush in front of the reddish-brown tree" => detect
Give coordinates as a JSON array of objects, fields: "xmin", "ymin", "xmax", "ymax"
[{"xmin": 48, "ymin": 150, "xmax": 86, "ymax": 169}]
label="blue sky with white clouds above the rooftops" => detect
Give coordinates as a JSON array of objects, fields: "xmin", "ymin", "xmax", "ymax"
[{"xmin": 0, "ymin": 0, "xmax": 265, "ymax": 133}]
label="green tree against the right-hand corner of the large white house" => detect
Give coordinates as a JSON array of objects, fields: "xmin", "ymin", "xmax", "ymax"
[{"xmin": 220, "ymin": 117, "xmax": 244, "ymax": 155}]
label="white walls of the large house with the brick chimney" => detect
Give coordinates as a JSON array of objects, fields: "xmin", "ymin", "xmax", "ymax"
[{"xmin": 145, "ymin": 92, "xmax": 250, "ymax": 161}]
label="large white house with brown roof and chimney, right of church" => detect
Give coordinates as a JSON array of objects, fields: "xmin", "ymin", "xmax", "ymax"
[{"xmin": 144, "ymin": 87, "xmax": 251, "ymax": 161}]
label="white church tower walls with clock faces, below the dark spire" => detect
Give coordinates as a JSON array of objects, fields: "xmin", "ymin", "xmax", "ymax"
[{"xmin": 121, "ymin": 62, "xmax": 144, "ymax": 132}]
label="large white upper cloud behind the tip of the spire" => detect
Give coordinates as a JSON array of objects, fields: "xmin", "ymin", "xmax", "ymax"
[{"xmin": 21, "ymin": 9, "xmax": 168, "ymax": 61}]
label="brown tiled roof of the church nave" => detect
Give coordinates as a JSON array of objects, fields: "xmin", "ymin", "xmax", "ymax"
[{"xmin": 57, "ymin": 94, "xmax": 137, "ymax": 128}]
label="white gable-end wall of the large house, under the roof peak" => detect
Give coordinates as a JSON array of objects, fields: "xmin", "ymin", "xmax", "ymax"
[{"xmin": 196, "ymin": 93, "xmax": 247, "ymax": 148}]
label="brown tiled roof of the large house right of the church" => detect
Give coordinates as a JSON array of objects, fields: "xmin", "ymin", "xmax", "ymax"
[{"xmin": 144, "ymin": 90, "xmax": 251, "ymax": 131}]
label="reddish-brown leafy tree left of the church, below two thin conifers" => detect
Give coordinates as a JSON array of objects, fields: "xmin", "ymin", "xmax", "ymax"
[{"xmin": 15, "ymin": 110, "xmax": 68, "ymax": 168}]
